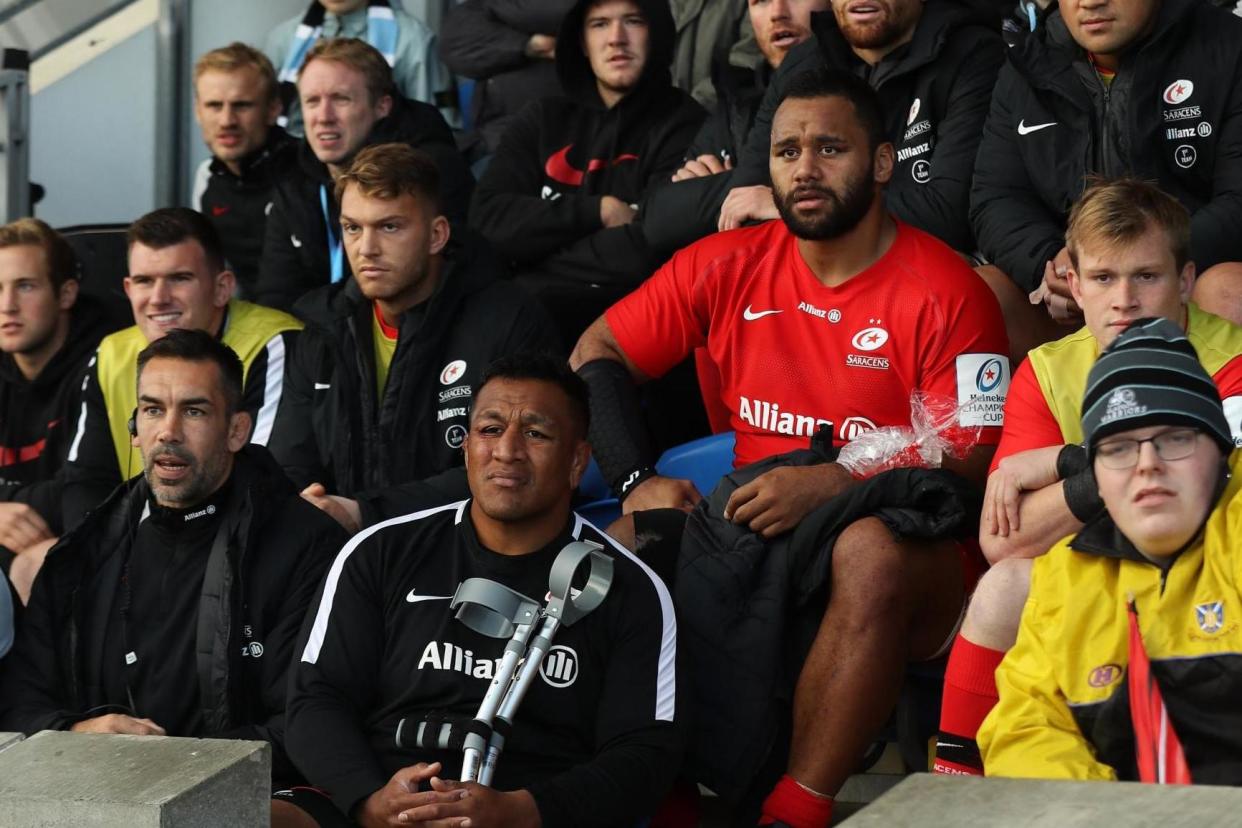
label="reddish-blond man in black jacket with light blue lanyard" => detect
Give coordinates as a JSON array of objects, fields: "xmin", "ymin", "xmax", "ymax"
[{"xmin": 258, "ymin": 38, "xmax": 474, "ymax": 310}]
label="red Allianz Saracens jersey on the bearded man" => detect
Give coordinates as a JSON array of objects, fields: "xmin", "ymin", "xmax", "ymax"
[{"xmin": 606, "ymin": 221, "xmax": 1010, "ymax": 466}]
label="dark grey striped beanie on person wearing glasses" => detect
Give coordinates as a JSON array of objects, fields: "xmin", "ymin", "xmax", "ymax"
[{"xmin": 1082, "ymin": 319, "xmax": 1233, "ymax": 456}]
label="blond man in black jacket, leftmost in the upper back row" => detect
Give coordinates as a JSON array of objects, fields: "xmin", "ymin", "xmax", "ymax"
[{"xmin": 194, "ymin": 43, "xmax": 294, "ymax": 298}]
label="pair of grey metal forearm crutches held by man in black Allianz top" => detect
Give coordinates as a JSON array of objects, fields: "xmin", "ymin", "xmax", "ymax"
[{"xmin": 452, "ymin": 541, "xmax": 612, "ymax": 785}]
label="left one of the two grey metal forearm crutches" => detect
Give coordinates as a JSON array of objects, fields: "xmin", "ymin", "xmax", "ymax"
[{"xmin": 452, "ymin": 578, "xmax": 542, "ymax": 782}]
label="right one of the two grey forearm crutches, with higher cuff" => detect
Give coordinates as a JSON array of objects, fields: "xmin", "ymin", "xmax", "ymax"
[{"xmin": 478, "ymin": 540, "xmax": 612, "ymax": 785}]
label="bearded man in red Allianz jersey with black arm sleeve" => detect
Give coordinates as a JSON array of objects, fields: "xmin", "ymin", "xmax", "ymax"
[{"xmin": 570, "ymin": 72, "xmax": 1009, "ymax": 827}]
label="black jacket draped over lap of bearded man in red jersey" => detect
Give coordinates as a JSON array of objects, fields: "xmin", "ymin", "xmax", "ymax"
[{"xmin": 674, "ymin": 448, "xmax": 980, "ymax": 807}]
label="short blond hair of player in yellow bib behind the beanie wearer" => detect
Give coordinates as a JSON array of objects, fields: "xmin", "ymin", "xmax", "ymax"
[{"xmin": 1066, "ymin": 178, "xmax": 1190, "ymax": 271}]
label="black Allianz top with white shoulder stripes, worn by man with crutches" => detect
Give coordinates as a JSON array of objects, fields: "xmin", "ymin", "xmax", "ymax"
[{"xmin": 288, "ymin": 502, "xmax": 684, "ymax": 828}]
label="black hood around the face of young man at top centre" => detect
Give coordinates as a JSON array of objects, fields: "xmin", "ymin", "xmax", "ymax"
[{"xmin": 556, "ymin": 0, "xmax": 676, "ymax": 107}]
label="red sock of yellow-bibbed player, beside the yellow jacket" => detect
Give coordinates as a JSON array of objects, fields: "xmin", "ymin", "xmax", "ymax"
[{"xmin": 932, "ymin": 633, "xmax": 1005, "ymax": 776}]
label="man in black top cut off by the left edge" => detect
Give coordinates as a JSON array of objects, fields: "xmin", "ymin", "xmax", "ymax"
[{"xmin": 0, "ymin": 218, "xmax": 111, "ymax": 590}]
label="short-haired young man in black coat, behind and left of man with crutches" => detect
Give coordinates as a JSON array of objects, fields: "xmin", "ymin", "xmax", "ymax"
[{"xmin": 270, "ymin": 141, "xmax": 554, "ymax": 495}]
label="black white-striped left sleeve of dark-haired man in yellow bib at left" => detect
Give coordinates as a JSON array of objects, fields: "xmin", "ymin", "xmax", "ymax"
[{"xmin": 61, "ymin": 360, "xmax": 122, "ymax": 531}]
